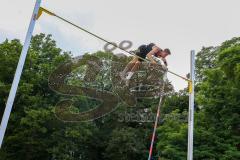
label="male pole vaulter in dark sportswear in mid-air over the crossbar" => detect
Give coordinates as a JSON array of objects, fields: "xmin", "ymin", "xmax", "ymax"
[{"xmin": 120, "ymin": 43, "xmax": 171, "ymax": 81}]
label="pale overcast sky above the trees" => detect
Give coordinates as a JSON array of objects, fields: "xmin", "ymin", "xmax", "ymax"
[{"xmin": 0, "ymin": 0, "xmax": 240, "ymax": 90}]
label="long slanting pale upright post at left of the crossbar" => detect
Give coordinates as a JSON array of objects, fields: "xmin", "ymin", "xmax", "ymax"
[{"xmin": 0, "ymin": 0, "xmax": 42, "ymax": 148}]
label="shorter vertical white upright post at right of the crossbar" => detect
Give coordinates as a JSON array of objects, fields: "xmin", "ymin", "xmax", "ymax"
[{"xmin": 187, "ymin": 50, "xmax": 195, "ymax": 160}]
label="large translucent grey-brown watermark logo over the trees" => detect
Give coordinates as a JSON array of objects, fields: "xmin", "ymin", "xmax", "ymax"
[{"xmin": 49, "ymin": 42, "xmax": 167, "ymax": 122}]
